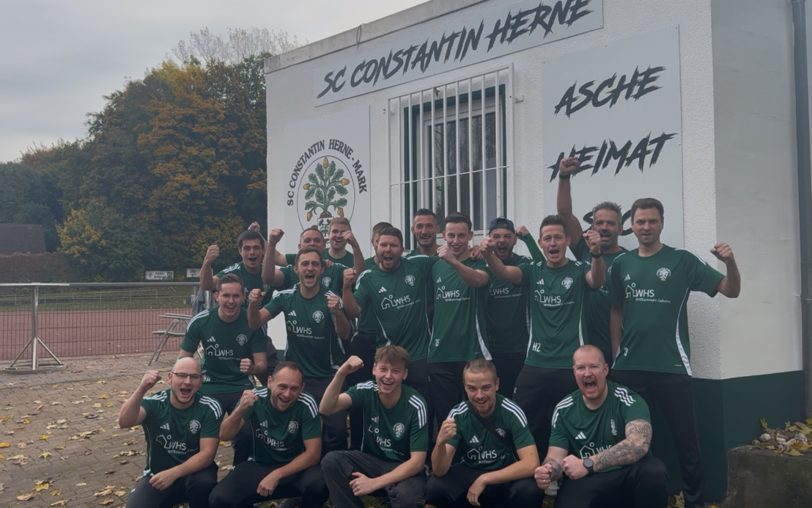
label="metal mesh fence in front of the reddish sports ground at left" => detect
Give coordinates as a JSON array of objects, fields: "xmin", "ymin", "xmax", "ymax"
[{"xmin": 0, "ymin": 282, "xmax": 197, "ymax": 363}]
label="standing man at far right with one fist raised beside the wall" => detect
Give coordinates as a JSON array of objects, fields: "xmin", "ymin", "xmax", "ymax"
[{"xmin": 609, "ymin": 198, "xmax": 741, "ymax": 507}]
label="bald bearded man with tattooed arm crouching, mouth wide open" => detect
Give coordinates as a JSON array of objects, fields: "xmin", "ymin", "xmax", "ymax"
[{"xmin": 535, "ymin": 345, "xmax": 668, "ymax": 508}]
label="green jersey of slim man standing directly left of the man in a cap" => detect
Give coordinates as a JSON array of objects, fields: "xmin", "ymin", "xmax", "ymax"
[{"xmin": 428, "ymin": 258, "xmax": 491, "ymax": 363}]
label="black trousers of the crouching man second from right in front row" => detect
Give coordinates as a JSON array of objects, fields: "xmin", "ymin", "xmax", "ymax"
[{"xmin": 426, "ymin": 464, "xmax": 544, "ymax": 508}]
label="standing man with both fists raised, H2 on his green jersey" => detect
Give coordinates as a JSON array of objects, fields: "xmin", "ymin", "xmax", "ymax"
[{"xmin": 482, "ymin": 215, "xmax": 605, "ymax": 458}]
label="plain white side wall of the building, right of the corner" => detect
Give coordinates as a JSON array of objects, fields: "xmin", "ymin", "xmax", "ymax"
[{"xmin": 708, "ymin": 0, "xmax": 802, "ymax": 378}]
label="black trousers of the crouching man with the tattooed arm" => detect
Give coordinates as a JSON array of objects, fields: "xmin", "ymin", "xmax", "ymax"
[{"xmin": 555, "ymin": 455, "xmax": 668, "ymax": 508}]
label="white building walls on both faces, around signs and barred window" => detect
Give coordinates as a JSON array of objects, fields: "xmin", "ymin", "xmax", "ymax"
[{"xmin": 267, "ymin": 0, "xmax": 801, "ymax": 379}]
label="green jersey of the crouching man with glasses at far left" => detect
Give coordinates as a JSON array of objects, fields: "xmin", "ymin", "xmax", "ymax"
[{"xmin": 141, "ymin": 389, "xmax": 223, "ymax": 475}]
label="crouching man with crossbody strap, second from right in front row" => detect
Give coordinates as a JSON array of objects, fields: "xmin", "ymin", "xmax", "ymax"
[{"xmin": 426, "ymin": 358, "xmax": 544, "ymax": 508}]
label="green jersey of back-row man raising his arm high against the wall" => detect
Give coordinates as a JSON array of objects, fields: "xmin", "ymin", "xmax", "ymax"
[{"xmin": 572, "ymin": 240, "xmax": 626, "ymax": 361}]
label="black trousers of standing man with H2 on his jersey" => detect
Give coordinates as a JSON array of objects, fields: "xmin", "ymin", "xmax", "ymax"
[{"xmin": 513, "ymin": 365, "xmax": 578, "ymax": 460}]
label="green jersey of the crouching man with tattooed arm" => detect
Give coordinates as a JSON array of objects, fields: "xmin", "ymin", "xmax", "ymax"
[{"xmin": 550, "ymin": 381, "xmax": 651, "ymax": 471}]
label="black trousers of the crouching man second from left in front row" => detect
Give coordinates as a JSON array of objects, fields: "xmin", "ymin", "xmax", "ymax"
[{"xmin": 209, "ymin": 461, "xmax": 327, "ymax": 508}]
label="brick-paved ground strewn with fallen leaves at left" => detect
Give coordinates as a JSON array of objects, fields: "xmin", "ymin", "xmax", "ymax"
[{"xmin": 0, "ymin": 354, "xmax": 239, "ymax": 507}]
